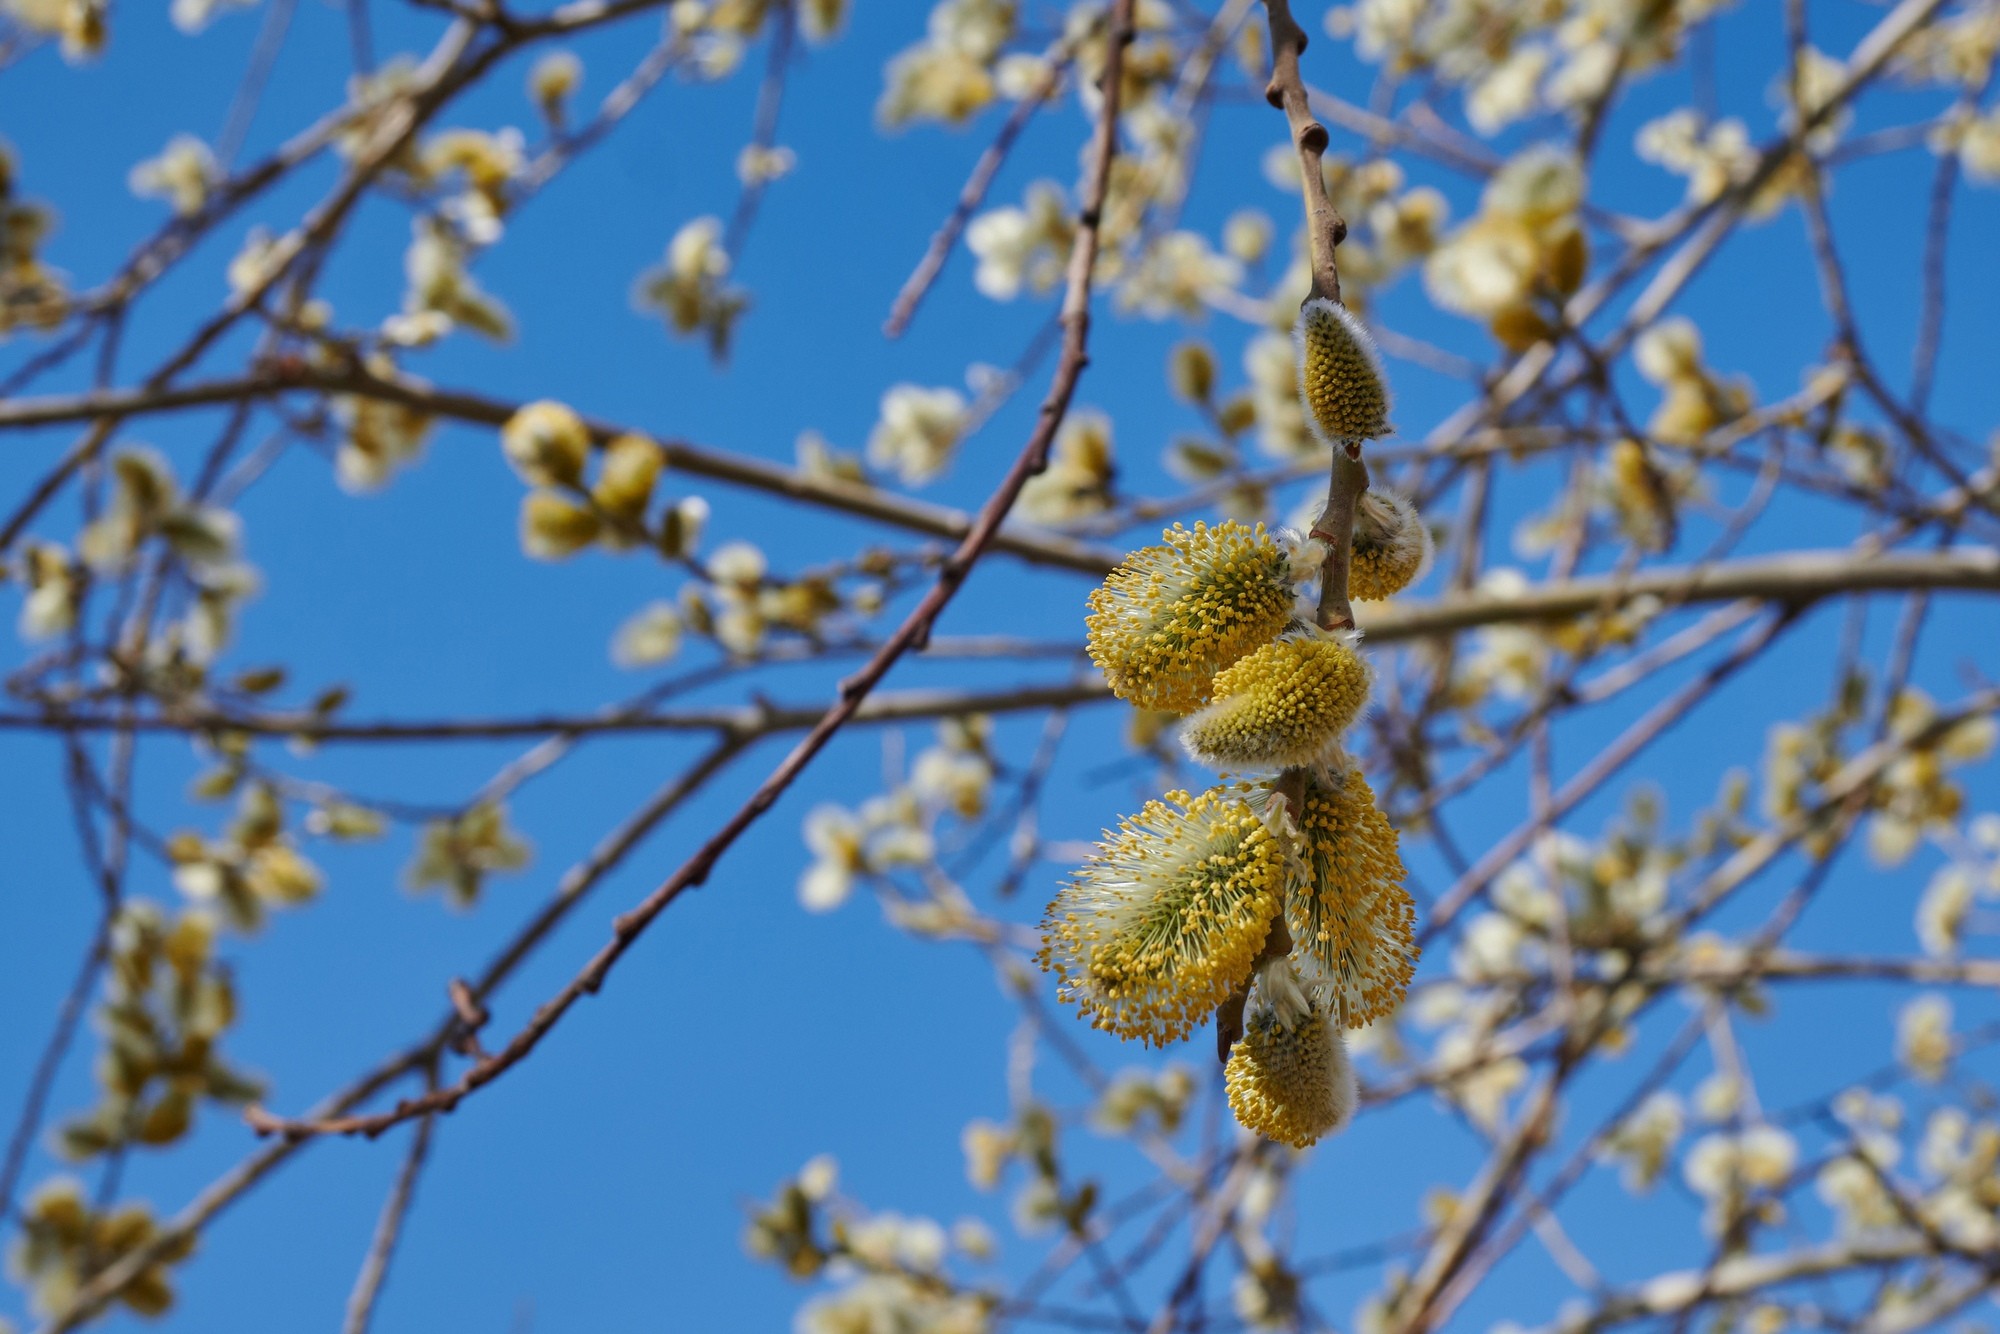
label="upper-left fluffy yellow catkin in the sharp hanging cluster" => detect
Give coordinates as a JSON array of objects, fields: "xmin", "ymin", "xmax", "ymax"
[{"xmin": 1084, "ymin": 524, "xmax": 1292, "ymax": 714}]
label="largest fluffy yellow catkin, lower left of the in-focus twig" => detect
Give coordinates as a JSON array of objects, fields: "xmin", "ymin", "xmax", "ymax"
[{"xmin": 1038, "ymin": 788, "xmax": 1286, "ymax": 1046}]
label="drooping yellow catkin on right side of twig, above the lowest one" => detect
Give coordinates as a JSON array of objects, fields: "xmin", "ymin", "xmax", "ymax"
[{"xmin": 1284, "ymin": 764, "xmax": 1416, "ymax": 1028}]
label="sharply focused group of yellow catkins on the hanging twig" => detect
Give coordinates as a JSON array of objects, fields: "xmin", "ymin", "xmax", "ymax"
[{"xmin": 1040, "ymin": 344, "xmax": 1430, "ymax": 1148}]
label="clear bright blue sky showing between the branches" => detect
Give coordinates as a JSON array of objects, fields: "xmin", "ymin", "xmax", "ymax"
[{"xmin": 0, "ymin": 0, "xmax": 2000, "ymax": 1334}]
